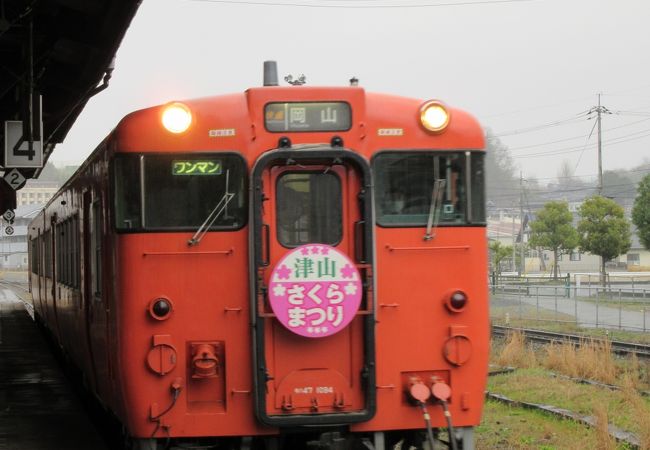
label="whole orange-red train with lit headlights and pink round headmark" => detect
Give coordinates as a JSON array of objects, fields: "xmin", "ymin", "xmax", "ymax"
[{"xmin": 29, "ymin": 64, "xmax": 489, "ymax": 450}]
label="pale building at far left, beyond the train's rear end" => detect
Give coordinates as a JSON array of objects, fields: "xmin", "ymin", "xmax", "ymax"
[{"xmin": 0, "ymin": 204, "xmax": 44, "ymax": 270}]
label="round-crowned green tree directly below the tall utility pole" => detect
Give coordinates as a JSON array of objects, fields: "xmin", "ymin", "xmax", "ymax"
[{"xmin": 578, "ymin": 196, "xmax": 631, "ymax": 285}]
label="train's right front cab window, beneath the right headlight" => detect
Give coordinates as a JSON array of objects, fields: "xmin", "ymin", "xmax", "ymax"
[{"xmin": 373, "ymin": 151, "xmax": 485, "ymax": 227}]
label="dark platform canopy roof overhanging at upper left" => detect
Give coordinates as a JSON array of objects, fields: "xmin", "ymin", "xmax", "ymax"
[{"xmin": 0, "ymin": 0, "xmax": 140, "ymax": 214}]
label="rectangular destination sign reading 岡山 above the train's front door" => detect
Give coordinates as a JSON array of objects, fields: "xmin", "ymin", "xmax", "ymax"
[{"xmin": 264, "ymin": 102, "xmax": 352, "ymax": 133}]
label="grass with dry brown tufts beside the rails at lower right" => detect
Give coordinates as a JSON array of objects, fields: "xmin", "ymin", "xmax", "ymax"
[{"xmin": 476, "ymin": 332, "xmax": 650, "ymax": 450}]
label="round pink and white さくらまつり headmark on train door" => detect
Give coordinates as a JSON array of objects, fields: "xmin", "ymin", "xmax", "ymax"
[{"xmin": 269, "ymin": 244, "xmax": 362, "ymax": 338}]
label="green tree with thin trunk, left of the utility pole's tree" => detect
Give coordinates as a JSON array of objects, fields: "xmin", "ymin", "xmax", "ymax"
[{"xmin": 529, "ymin": 201, "xmax": 579, "ymax": 280}]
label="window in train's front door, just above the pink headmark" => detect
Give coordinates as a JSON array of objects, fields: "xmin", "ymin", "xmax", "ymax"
[{"xmin": 276, "ymin": 172, "xmax": 343, "ymax": 247}]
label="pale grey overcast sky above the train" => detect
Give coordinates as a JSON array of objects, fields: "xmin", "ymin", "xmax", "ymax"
[{"xmin": 50, "ymin": 0, "xmax": 650, "ymax": 182}]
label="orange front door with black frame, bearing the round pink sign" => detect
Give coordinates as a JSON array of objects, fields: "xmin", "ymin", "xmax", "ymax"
[{"xmin": 251, "ymin": 147, "xmax": 375, "ymax": 426}]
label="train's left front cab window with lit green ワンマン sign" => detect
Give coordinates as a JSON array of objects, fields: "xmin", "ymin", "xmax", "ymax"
[{"xmin": 114, "ymin": 153, "xmax": 247, "ymax": 231}]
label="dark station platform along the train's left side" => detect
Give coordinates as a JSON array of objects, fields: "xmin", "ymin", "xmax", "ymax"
[{"xmin": 0, "ymin": 273, "xmax": 109, "ymax": 450}]
